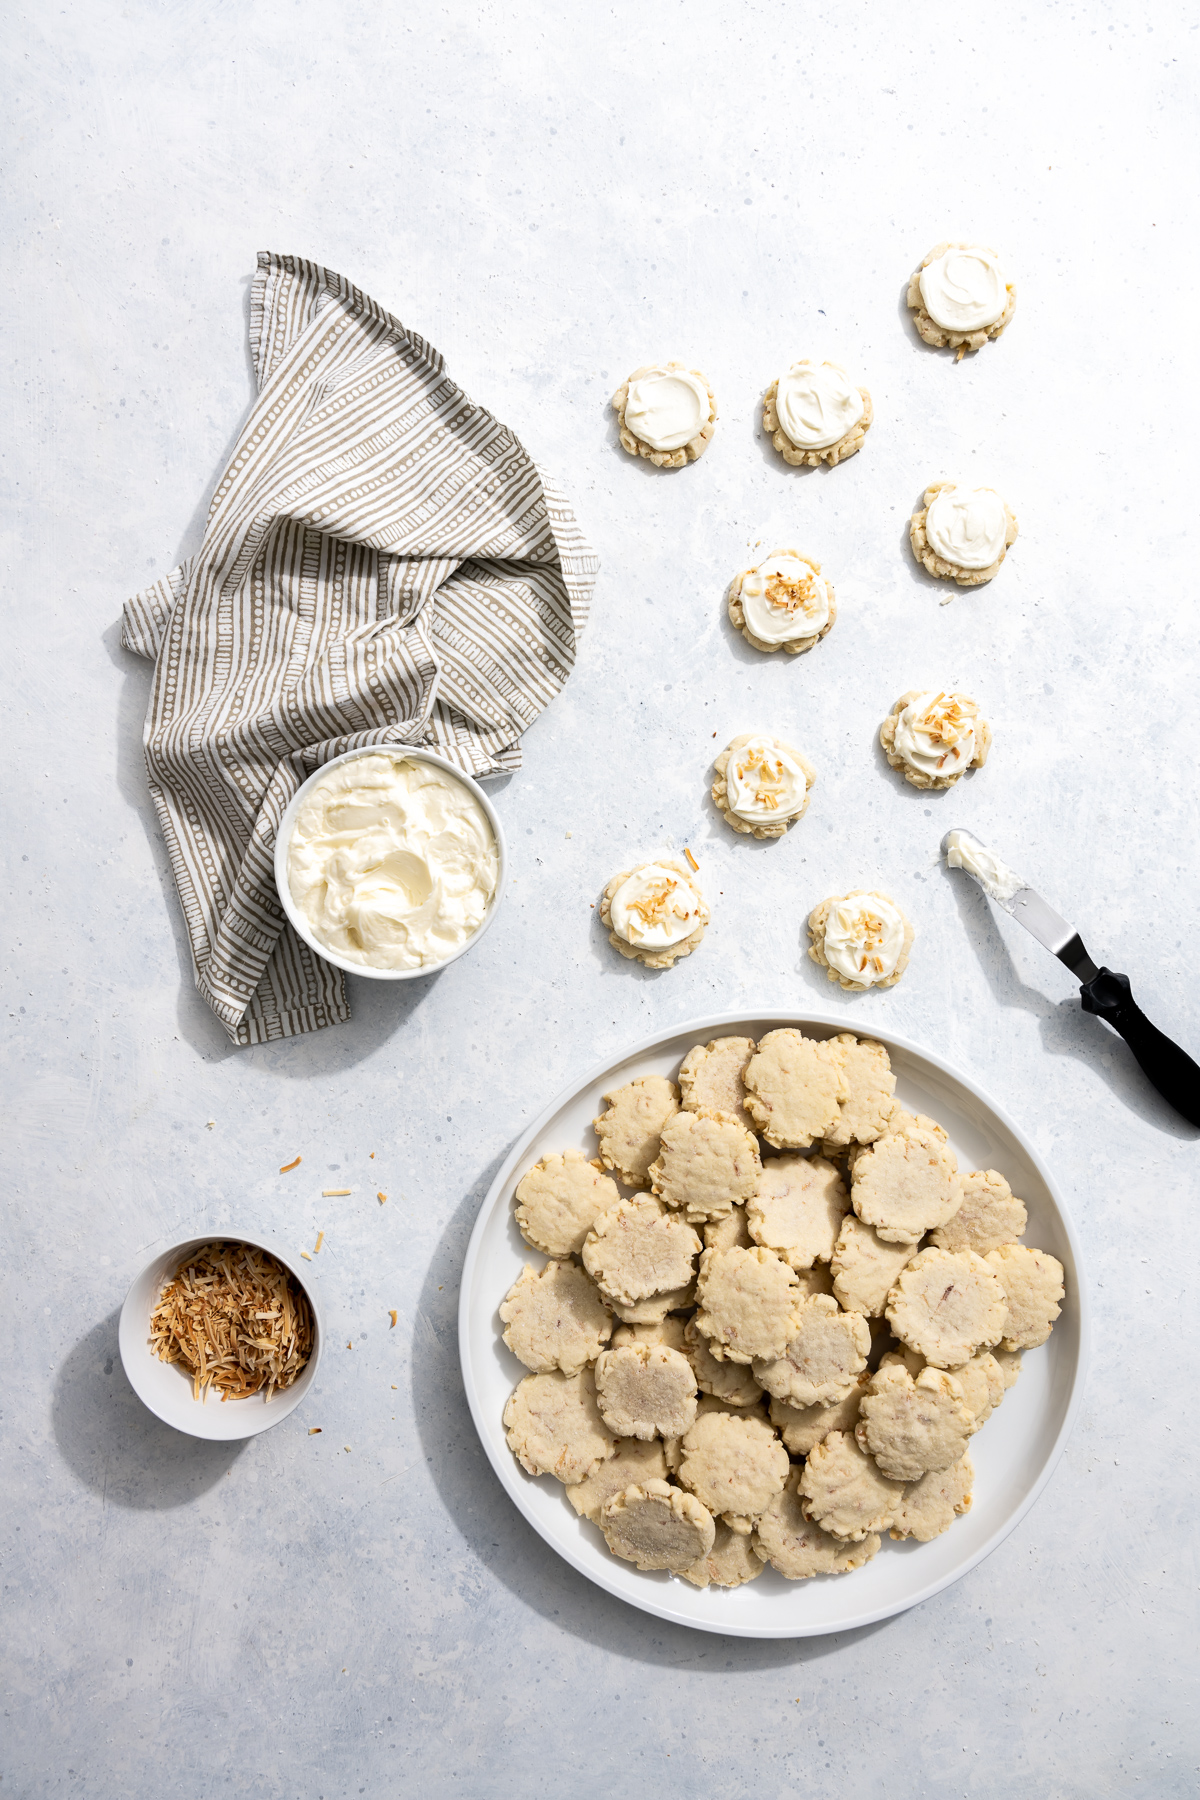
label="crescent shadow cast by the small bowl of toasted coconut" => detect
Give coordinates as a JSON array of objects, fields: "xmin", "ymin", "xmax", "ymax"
[{"xmin": 50, "ymin": 1310, "xmax": 245, "ymax": 1512}]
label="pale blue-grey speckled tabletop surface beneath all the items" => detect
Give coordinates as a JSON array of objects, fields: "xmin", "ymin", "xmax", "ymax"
[{"xmin": 0, "ymin": 0, "xmax": 1200, "ymax": 1800}]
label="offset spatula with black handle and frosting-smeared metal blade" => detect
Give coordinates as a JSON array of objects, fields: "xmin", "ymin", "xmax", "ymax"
[{"xmin": 941, "ymin": 832, "xmax": 1200, "ymax": 1125}]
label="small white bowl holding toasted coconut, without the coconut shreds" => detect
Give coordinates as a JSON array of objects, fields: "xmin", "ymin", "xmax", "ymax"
[{"xmin": 117, "ymin": 1231, "xmax": 324, "ymax": 1442}]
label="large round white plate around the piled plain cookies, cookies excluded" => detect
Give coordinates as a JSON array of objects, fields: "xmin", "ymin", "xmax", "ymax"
[{"xmin": 459, "ymin": 1013, "xmax": 1088, "ymax": 1638}]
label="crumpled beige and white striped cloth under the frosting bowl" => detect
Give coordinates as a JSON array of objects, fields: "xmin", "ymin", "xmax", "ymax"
[{"xmin": 124, "ymin": 254, "xmax": 597, "ymax": 1044}]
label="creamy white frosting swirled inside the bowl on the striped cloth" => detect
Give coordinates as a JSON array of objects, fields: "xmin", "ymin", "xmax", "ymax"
[{"xmin": 288, "ymin": 752, "xmax": 500, "ymax": 968}]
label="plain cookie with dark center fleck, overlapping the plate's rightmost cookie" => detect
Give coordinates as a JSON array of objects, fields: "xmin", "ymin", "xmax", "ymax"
[{"xmin": 887, "ymin": 1249, "xmax": 1007, "ymax": 1368}]
